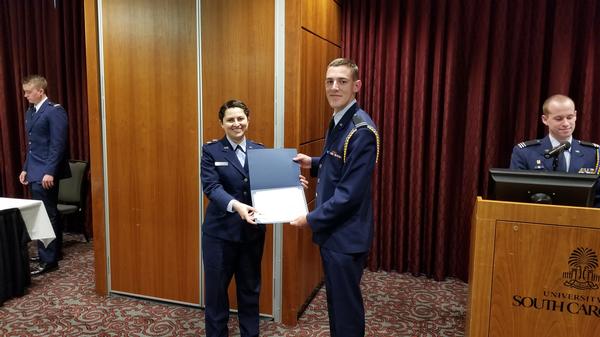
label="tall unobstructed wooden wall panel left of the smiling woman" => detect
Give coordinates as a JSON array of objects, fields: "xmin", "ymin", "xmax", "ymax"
[{"xmin": 102, "ymin": 0, "xmax": 199, "ymax": 303}]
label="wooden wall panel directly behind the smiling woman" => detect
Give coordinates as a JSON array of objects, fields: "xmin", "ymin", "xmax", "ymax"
[{"xmin": 201, "ymin": 0, "xmax": 275, "ymax": 315}]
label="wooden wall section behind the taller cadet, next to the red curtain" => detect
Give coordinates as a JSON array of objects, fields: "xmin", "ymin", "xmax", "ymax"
[{"xmin": 282, "ymin": 0, "xmax": 341, "ymax": 325}]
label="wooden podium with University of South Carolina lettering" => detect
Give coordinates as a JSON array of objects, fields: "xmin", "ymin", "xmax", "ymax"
[{"xmin": 467, "ymin": 197, "xmax": 600, "ymax": 337}]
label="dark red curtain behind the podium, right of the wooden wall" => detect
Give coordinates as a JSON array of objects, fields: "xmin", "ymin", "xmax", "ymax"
[{"xmin": 342, "ymin": 0, "xmax": 600, "ymax": 280}]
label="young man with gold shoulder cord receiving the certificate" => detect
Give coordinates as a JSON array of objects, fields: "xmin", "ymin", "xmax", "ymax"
[{"xmin": 291, "ymin": 58, "xmax": 379, "ymax": 337}]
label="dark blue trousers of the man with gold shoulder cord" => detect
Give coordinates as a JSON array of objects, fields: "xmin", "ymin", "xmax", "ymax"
[{"xmin": 321, "ymin": 247, "xmax": 368, "ymax": 337}]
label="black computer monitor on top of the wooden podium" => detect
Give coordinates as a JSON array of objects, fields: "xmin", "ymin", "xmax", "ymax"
[{"xmin": 487, "ymin": 168, "xmax": 599, "ymax": 207}]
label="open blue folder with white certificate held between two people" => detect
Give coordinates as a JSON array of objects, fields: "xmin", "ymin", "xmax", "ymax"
[{"xmin": 248, "ymin": 149, "xmax": 308, "ymax": 223}]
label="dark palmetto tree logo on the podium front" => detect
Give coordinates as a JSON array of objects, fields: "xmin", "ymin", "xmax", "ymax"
[{"xmin": 563, "ymin": 247, "xmax": 600, "ymax": 290}]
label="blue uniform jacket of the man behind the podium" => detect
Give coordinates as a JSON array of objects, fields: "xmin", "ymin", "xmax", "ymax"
[{"xmin": 510, "ymin": 136, "xmax": 600, "ymax": 207}]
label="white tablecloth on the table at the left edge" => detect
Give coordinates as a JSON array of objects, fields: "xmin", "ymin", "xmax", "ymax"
[{"xmin": 0, "ymin": 198, "xmax": 56, "ymax": 247}]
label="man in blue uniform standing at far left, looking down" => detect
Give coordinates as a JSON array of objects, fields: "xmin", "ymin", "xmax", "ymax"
[{"xmin": 19, "ymin": 75, "xmax": 71, "ymax": 275}]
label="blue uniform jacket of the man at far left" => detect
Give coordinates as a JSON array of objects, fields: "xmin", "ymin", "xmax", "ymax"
[{"xmin": 23, "ymin": 100, "xmax": 71, "ymax": 182}]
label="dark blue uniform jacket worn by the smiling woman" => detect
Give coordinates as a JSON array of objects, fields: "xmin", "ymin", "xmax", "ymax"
[{"xmin": 200, "ymin": 137, "xmax": 265, "ymax": 242}]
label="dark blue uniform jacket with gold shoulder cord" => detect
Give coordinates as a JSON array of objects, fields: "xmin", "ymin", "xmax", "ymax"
[{"xmin": 307, "ymin": 104, "xmax": 377, "ymax": 254}]
